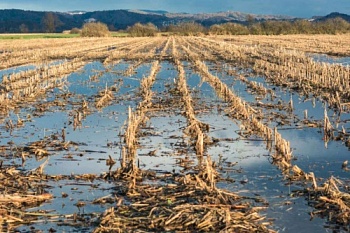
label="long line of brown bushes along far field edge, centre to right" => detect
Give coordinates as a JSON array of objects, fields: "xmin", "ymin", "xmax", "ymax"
[{"xmin": 127, "ymin": 18, "xmax": 350, "ymax": 36}]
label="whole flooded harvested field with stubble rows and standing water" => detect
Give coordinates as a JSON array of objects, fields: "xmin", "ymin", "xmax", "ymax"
[{"xmin": 0, "ymin": 35, "xmax": 350, "ymax": 232}]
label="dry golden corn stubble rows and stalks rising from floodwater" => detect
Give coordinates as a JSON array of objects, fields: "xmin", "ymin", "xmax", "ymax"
[{"xmin": 0, "ymin": 35, "xmax": 350, "ymax": 232}]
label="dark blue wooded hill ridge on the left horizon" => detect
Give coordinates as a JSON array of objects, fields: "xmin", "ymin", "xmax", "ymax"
[{"xmin": 0, "ymin": 9, "xmax": 169, "ymax": 33}]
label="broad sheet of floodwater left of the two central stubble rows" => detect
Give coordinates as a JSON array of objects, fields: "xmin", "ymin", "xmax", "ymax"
[{"xmin": 8, "ymin": 62, "xmax": 150, "ymax": 232}]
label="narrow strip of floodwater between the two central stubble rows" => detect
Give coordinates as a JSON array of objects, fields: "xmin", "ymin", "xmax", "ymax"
[{"xmin": 138, "ymin": 62, "xmax": 186, "ymax": 174}]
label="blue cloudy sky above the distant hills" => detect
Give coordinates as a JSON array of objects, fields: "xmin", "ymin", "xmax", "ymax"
[{"xmin": 0, "ymin": 0, "xmax": 350, "ymax": 17}]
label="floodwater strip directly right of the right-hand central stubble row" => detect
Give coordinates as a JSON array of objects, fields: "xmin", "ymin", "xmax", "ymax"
[{"xmin": 188, "ymin": 64, "xmax": 325, "ymax": 232}]
